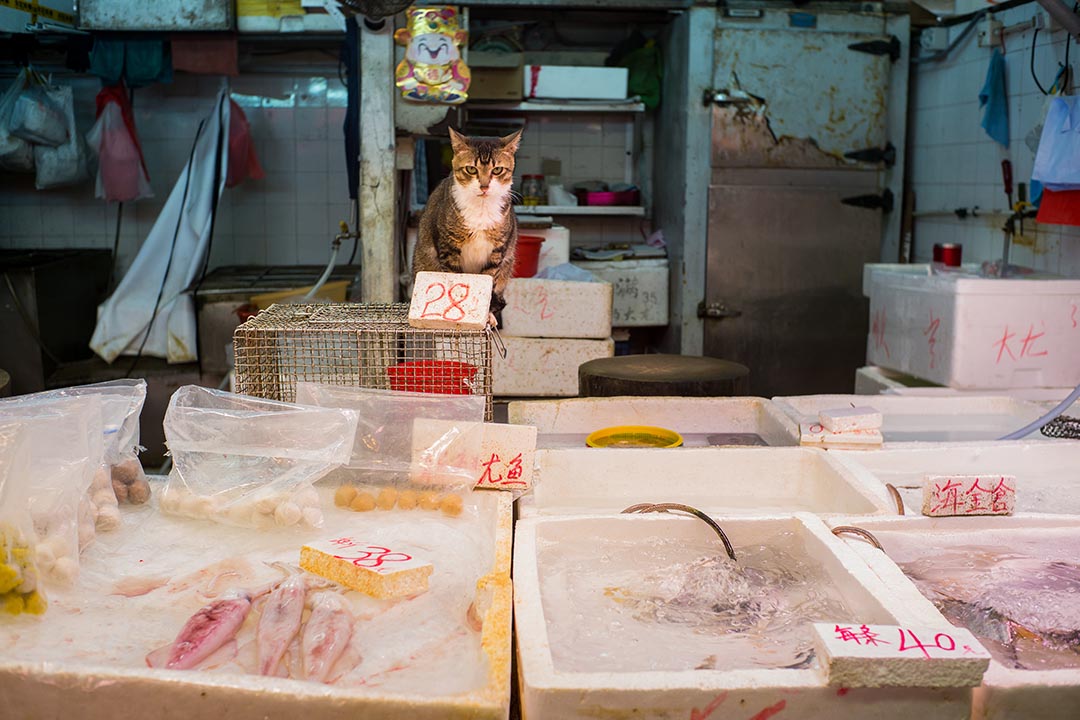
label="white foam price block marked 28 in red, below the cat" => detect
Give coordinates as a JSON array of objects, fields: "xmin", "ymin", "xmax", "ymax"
[{"xmin": 408, "ymin": 272, "xmax": 491, "ymax": 330}]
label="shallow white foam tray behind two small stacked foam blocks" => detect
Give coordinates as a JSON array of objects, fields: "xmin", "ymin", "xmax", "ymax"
[{"xmin": 772, "ymin": 395, "xmax": 1044, "ymax": 447}]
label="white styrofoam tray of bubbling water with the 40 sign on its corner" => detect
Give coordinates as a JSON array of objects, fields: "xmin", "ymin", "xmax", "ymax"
[{"xmin": 514, "ymin": 514, "xmax": 970, "ymax": 720}]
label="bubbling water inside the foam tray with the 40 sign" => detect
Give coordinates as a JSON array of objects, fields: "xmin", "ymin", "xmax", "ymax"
[{"xmin": 538, "ymin": 533, "xmax": 850, "ymax": 673}]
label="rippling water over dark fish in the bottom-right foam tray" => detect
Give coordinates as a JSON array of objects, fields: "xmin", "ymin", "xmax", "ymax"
[{"xmin": 877, "ymin": 531, "xmax": 1080, "ymax": 670}]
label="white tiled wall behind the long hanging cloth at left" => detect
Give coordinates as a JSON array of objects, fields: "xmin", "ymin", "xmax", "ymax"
[{"xmin": 0, "ymin": 67, "xmax": 349, "ymax": 272}]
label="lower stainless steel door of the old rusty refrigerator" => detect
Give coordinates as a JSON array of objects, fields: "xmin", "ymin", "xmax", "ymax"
[{"xmin": 705, "ymin": 171, "xmax": 881, "ymax": 397}]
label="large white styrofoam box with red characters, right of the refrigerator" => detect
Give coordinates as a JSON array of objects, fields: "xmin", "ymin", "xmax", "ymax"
[{"xmin": 863, "ymin": 264, "xmax": 1080, "ymax": 389}]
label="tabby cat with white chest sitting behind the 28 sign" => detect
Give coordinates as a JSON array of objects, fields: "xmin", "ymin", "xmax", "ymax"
[{"xmin": 413, "ymin": 127, "xmax": 522, "ymax": 321}]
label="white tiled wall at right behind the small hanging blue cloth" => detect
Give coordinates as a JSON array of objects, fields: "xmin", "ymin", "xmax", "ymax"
[{"xmin": 909, "ymin": 0, "xmax": 1080, "ymax": 277}]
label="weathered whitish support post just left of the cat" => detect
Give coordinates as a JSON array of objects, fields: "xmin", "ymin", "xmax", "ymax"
[{"xmin": 354, "ymin": 18, "xmax": 399, "ymax": 302}]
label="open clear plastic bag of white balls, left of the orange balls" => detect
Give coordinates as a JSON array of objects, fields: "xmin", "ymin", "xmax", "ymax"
[{"xmin": 159, "ymin": 385, "xmax": 356, "ymax": 529}]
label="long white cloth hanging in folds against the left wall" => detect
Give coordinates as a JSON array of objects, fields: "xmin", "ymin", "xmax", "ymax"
[{"xmin": 90, "ymin": 85, "xmax": 229, "ymax": 363}]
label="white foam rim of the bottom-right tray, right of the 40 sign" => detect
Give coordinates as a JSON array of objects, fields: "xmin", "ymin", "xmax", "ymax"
[{"xmin": 837, "ymin": 516, "xmax": 1080, "ymax": 720}]
